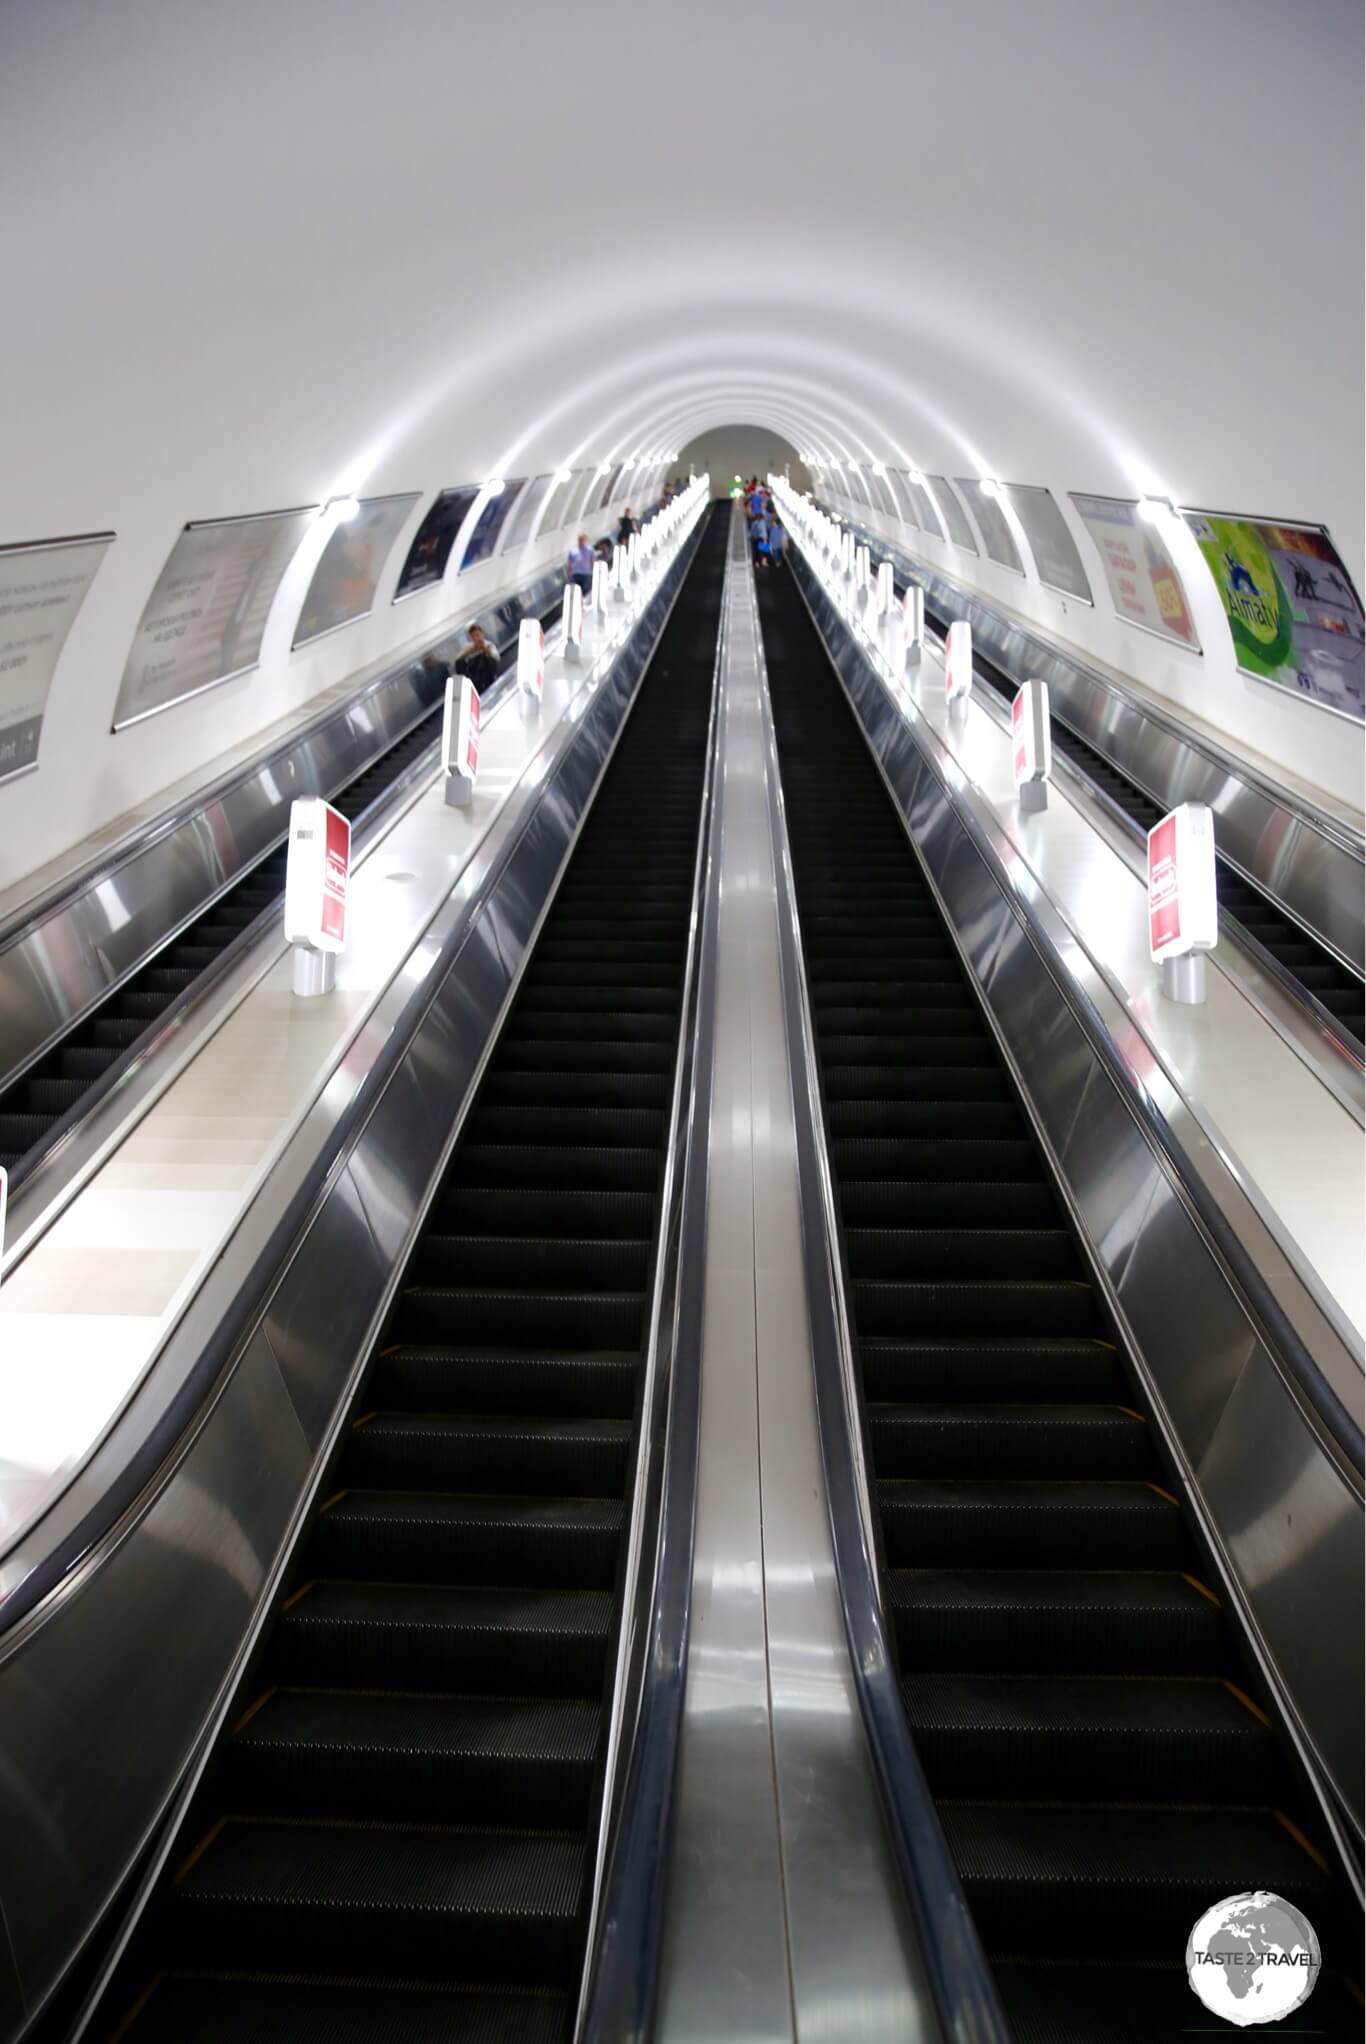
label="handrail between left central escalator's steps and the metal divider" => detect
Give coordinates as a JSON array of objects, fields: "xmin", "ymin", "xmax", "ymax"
[{"xmin": 575, "ymin": 513, "xmax": 726, "ymax": 2040}]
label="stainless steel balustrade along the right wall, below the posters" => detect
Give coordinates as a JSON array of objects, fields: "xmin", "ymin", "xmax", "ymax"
[{"xmin": 822, "ymin": 500, "xmax": 1366, "ymax": 973}]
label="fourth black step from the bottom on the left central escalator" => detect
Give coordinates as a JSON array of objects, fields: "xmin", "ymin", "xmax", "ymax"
[{"xmin": 270, "ymin": 1580, "xmax": 611, "ymax": 1699}]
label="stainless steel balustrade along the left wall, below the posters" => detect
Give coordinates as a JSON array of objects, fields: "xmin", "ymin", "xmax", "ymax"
[{"xmin": 0, "ymin": 566, "xmax": 560, "ymax": 1083}]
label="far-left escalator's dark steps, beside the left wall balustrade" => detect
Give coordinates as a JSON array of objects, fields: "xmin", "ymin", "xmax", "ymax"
[{"xmin": 0, "ymin": 601, "xmax": 560, "ymax": 1179}]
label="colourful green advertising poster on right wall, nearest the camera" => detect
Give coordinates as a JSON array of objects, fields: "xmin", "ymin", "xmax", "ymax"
[{"xmin": 1182, "ymin": 511, "xmax": 1366, "ymax": 719}]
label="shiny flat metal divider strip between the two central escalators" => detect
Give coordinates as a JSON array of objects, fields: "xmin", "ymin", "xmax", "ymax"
[{"xmin": 654, "ymin": 506, "xmax": 939, "ymax": 2044}]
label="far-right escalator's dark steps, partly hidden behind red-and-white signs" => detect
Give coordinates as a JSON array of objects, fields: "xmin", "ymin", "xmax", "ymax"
[{"xmin": 879, "ymin": 555, "xmax": 1366, "ymax": 1055}]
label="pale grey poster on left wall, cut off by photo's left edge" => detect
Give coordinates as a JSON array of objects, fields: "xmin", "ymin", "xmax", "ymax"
[{"xmin": 0, "ymin": 531, "xmax": 112, "ymax": 781}]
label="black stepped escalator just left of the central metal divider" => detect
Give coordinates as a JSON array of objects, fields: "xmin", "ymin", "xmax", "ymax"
[{"xmin": 84, "ymin": 509, "xmax": 728, "ymax": 2044}]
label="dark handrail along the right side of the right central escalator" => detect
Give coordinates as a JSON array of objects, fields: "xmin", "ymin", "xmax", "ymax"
[{"xmin": 798, "ymin": 535, "xmax": 1366, "ymax": 1480}]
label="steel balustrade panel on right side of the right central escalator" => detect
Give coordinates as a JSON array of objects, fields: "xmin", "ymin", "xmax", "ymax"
[{"xmin": 793, "ymin": 550, "xmax": 1366, "ymax": 1829}]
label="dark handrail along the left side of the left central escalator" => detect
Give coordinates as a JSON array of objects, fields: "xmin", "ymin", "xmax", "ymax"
[{"xmin": 0, "ymin": 515, "xmax": 697, "ymax": 1641}]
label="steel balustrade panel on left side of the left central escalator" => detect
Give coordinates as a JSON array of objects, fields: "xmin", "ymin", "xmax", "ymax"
[{"xmin": 0, "ymin": 538, "xmax": 695, "ymax": 2040}]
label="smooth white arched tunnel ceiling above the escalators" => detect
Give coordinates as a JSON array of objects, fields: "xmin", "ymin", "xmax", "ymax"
[{"xmin": 0, "ymin": 0, "xmax": 1362, "ymax": 574}]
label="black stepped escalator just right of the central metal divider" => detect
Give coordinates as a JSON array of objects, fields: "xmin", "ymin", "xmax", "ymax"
[{"xmin": 757, "ymin": 551, "xmax": 1362, "ymax": 2044}]
